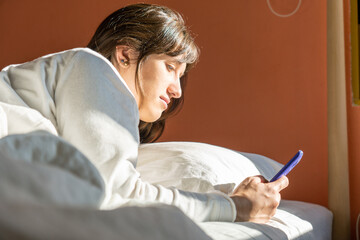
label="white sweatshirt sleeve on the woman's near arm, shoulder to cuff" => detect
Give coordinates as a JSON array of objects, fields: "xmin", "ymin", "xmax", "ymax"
[{"xmin": 55, "ymin": 51, "xmax": 236, "ymax": 221}]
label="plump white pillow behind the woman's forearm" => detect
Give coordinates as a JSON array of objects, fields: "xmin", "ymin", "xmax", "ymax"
[{"xmin": 137, "ymin": 142, "xmax": 282, "ymax": 194}]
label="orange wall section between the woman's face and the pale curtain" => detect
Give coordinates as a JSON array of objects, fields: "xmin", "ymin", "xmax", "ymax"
[{"xmin": 161, "ymin": 0, "xmax": 328, "ymax": 205}]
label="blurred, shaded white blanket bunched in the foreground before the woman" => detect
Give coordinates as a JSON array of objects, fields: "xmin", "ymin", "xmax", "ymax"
[{"xmin": 0, "ymin": 131, "xmax": 210, "ymax": 240}]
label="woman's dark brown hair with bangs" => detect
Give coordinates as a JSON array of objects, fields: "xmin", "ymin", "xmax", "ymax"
[{"xmin": 87, "ymin": 4, "xmax": 199, "ymax": 143}]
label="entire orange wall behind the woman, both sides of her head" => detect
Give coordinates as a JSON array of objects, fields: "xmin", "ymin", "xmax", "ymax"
[{"xmin": 0, "ymin": 0, "xmax": 328, "ymax": 206}]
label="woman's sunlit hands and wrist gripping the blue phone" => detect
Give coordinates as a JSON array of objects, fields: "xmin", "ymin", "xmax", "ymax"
[{"xmin": 231, "ymin": 176, "xmax": 289, "ymax": 223}]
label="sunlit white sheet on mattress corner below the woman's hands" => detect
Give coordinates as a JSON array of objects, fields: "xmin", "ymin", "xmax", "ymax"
[{"xmin": 198, "ymin": 200, "xmax": 332, "ymax": 240}]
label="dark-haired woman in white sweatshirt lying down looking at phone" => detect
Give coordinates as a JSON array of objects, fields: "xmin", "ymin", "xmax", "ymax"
[{"xmin": 0, "ymin": 4, "xmax": 288, "ymax": 222}]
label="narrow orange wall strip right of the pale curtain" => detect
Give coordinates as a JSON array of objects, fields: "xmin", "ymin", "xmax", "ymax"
[{"xmin": 344, "ymin": 0, "xmax": 360, "ymax": 236}]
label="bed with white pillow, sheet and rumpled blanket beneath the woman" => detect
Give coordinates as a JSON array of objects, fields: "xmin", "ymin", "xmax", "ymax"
[{"xmin": 0, "ymin": 129, "xmax": 332, "ymax": 240}]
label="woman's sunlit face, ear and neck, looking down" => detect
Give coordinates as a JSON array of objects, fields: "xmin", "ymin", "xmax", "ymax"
[{"xmin": 119, "ymin": 49, "xmax": 186, "ymax": 122}]
